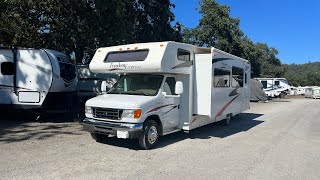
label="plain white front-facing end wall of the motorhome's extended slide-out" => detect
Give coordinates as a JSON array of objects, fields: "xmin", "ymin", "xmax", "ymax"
[{"xmin": 193, "ymin": 54, "xmax": 212, "ymax": 117}]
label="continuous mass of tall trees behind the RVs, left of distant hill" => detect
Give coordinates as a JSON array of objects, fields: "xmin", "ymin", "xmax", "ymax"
[{"xmin": 0, "ymin": 0, "xmax": 287, "ymax": 77}]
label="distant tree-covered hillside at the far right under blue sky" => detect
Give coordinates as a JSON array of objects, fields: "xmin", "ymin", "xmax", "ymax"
[{"xmin": 284, "ymin": 62, "xmax": 320, "ymax": 86}]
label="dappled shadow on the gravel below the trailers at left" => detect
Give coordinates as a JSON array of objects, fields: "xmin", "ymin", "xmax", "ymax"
[{"xmin": 0, "ymin": 112, "xmax": 84, "ymax": 143}]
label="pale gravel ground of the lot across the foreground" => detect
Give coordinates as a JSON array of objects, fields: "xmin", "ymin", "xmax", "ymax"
[{"xmin": 0, "ymin": 99, "xmax": 320, "ymax": 179}]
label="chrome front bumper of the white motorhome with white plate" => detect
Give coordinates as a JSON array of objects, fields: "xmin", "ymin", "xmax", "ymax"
[{"xmin": 82, "ymin": 118, "xmax": 143, "ymax": 139}]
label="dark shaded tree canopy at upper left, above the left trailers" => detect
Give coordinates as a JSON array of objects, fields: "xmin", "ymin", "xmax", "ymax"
[{"xmin": 0, "ymin": 0, "xmax": 181, "ymax": 62}]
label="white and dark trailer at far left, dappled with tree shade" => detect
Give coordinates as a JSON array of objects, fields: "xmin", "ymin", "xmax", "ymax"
[{"xmin": 0, "ymin": 48, "xmax": 77, "ymax": 116}]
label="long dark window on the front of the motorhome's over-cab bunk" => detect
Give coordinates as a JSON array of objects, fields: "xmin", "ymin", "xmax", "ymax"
[{"xmin": 104, "ymin": 49, "xmax": 149, "ymax": 62}]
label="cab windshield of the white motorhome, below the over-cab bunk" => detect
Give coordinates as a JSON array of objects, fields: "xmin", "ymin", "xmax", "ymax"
[{"xmin": 108, "ymin": 74, "xmax": 163, "ymax": 96}]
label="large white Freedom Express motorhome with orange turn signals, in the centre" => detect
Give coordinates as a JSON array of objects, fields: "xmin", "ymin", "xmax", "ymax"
[{"xmin": 83, "ymin": 42, "xmax": 251, "ymax": 149}]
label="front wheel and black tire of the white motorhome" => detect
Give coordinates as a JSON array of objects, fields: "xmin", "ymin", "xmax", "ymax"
[{"xmin": 139, "ymin": 120, "xmax": 160, "ymax": 150}]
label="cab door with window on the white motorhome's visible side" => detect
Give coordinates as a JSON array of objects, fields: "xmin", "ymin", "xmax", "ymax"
[{"xmin": 161, "ymin": 77, "xmax": 180, "ymax": 132}]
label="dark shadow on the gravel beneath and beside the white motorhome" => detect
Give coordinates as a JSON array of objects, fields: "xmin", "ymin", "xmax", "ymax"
[{"xmin": 96, "ymin": 113, "xmax": 264, "ymax": 150}]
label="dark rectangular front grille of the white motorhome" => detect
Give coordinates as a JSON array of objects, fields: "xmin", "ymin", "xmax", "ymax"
[{"xmin": 92, "ymin": 107, "xmax": 123, "ymax": 120}]
